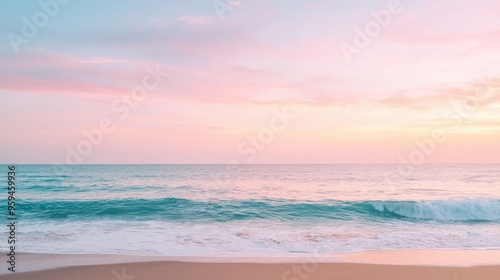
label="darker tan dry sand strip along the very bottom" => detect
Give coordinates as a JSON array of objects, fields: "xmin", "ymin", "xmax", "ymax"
[{"xmin": 0, "ymin": 261, "xmax": 500, "ymax": 280}]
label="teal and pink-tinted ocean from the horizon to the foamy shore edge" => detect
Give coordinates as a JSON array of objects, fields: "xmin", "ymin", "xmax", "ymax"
[{"xmin": 0, "ymin": 165, "xmax": 500, "ymax": 256}]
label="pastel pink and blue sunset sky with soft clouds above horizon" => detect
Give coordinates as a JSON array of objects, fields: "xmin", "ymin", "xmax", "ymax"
[{"xmin": 0, "ymin": 0, "xmax": 500, "ymax": 164}]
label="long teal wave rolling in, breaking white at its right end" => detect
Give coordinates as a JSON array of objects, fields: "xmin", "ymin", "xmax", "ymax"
[{"xmin": 18, "ymin": 197, "xmax": 500, "ymax": 222}]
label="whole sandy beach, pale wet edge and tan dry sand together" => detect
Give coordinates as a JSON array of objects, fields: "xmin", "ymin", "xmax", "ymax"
[{"xmin": 0, "ymin": 251, "xmax": 500, "ymax": 280}]
